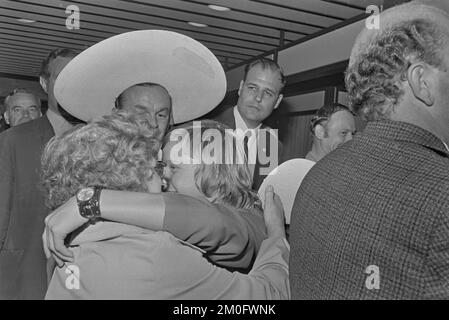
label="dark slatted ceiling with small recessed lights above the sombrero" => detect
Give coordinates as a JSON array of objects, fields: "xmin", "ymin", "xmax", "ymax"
[{"xmin": 0, "ymin": 0, "xmax": 374, "ymax": 77}]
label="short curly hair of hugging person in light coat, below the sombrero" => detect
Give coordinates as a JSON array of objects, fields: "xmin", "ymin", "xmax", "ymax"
[{"xmin": 41, "ymin": 107, "xmax": 160, "ymax": 209}]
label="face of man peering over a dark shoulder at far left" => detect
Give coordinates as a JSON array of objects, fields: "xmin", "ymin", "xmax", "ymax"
[{"xmin": 4, "ymin": 88, "xmax": 42, "ymax": 127}]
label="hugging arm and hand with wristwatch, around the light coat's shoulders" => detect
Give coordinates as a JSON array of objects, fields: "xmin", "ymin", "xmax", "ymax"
[{"xmin": 43, "ymin": 190, "xmax": 265, "ymax": 268}]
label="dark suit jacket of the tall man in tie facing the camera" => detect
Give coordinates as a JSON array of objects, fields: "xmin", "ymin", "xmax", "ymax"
[{"xmin": 214, "ymin": 107, "xmax": 283, "ymax": 190}]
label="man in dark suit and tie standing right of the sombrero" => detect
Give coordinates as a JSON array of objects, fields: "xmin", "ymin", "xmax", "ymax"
[{"xmin": 214, "ymin": 58, "xmax": 285, "ymax": 190}]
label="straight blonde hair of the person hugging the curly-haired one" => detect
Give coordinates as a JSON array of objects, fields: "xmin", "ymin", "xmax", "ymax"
[{"xmin": 163, "ymin": 120, "xmax": 260, "ymax": 209}]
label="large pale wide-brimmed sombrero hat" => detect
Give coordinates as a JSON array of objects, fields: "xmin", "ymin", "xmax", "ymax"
[{"xmin": 54, "ymin": 30, "xmax": 226, "ymax": 123}]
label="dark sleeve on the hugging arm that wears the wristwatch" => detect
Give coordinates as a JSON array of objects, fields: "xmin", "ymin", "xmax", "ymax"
[{"xmin": 163, "ymin": 193, "xmax": 266, "ymax": 269}]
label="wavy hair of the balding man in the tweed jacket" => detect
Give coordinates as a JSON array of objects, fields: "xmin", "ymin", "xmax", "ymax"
[{"xmin": 345, "ymin": 19, "xmax": 448, "ymax": 121}]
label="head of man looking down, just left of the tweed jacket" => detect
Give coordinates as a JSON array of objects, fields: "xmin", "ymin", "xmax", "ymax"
[{"xmin": 306, "ymin": 103, "xmax": 355, "ymax": 162}]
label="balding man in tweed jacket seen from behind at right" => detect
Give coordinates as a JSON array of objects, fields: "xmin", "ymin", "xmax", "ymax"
[{"xmin": 290, "ymin": 1, "xmax": 449, "ymax": 299}]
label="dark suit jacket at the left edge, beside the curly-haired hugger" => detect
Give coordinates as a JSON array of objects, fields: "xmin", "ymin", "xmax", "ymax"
[{"xmin": 0, "ymin": 116, "xmax": 54, "ymax": 299}]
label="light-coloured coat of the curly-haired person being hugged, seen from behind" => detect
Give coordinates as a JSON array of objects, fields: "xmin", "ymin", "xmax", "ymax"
[{"xmin": 46, "ymin": 222, "xmax": 290, "ymax": 300}]
